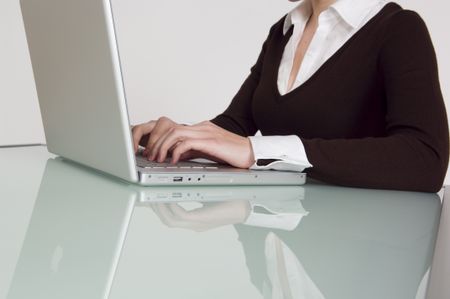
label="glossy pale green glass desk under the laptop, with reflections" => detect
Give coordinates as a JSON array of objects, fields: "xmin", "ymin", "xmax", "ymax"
[{"xmin": 0, "ymin": 147, "xmax": 441, "ymax": 299}]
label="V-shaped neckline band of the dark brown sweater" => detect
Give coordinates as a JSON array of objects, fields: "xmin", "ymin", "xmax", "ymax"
[{"xmin": 271, "ymin": 2, "xmax": 398, "ymax": 101}]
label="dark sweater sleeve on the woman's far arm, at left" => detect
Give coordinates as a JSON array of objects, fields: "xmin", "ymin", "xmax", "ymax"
[{"xmin": 211, "ymin": 19, "xmax": 283, "ymax": 136}]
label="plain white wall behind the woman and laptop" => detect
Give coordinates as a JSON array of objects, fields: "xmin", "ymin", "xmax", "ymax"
[{"xmin": 0, "ymin": 0, "xmax": 450, "ymax": 183}]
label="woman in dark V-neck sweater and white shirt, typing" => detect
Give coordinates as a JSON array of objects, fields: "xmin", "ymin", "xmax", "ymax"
[{"xmin": 133, "ymin": 0, "xmax": 449, "ymax": 192}]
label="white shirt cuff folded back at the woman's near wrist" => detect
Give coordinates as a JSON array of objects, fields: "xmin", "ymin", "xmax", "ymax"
[{"xmin": 248, "ymin": 135, "xmax": 312, "ymax": 172}]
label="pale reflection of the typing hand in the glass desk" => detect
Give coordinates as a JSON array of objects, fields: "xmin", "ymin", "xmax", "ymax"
[{"xmin": 150, "ymin": 200, "xmax": 251, "ymax": 232}]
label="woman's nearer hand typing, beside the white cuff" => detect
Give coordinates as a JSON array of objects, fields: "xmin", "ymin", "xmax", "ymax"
[{"xmin": 149, "ymin": 121, "xmax": 255, "ymax": 168}]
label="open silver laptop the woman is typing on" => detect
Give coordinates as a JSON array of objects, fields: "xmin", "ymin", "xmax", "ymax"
[{"xmin": 20, "ymin": 0, "xmax": 306, "ymax": 185}]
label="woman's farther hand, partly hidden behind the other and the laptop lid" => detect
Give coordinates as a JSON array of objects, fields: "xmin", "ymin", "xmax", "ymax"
[{"xmin": 131, "ymin": 116, "xmax": 182, "ymax": 157}]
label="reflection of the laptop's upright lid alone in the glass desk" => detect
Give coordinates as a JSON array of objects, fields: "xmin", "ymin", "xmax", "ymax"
[{"xmin": 7, "ymin": 159, "xmax": 136, "ymax": 299}]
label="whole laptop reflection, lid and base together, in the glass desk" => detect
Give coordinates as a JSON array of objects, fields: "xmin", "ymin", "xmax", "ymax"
[{"xmin": 6, "ymin": 157, "xmax": 304, "ymax": 299}]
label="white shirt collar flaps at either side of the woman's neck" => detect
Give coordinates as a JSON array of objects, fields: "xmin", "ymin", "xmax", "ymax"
[{"xmin": 283, "ymin": 0, "xmax": 385, "ymax": 34}]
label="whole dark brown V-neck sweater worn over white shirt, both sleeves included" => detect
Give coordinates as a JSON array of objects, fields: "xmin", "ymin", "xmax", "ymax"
[{"xmin": 212, "ymin": 3, "xmax": 449, "ymax": 192}]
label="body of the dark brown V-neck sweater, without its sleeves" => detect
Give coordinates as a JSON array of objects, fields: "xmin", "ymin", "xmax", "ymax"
[{"xmin": 252, "ymin": 3, "xmax": 402, "ymax": 138}]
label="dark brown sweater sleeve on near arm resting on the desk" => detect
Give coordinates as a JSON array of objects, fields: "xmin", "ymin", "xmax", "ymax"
[{"xmin": 302, "ymin": 10, "xmax": 449, "ymax": 192}]
